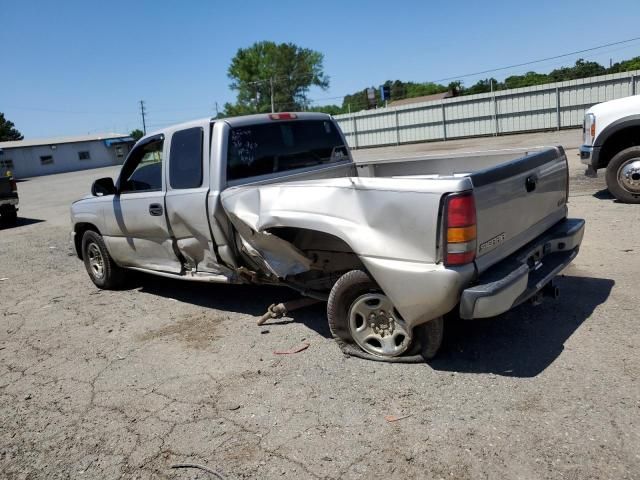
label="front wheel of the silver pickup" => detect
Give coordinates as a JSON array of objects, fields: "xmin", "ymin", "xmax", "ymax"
[{"xmin": 82, "ymin": 230, "xmax": 125, "ymax": 290}]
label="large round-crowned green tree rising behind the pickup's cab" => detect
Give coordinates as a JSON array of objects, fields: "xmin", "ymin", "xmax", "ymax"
[{"xmin": 225, "ymin": 42, "xmax": 329, "ymax": 115}]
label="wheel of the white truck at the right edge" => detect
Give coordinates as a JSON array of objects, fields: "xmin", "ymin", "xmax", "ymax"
[{"xmin": 606, "ymin": 147, "xmax": 640, "ymax": 203}]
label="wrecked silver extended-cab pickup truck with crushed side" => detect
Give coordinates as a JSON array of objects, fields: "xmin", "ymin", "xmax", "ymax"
[{"xmin": 71, "ymin": 113, "xmax": 584, "ymax": 361}]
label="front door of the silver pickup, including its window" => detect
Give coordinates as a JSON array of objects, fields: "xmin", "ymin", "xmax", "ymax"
[{"xmin": 105, "ymin": 135, "xmax": 182, "ymax": 273}]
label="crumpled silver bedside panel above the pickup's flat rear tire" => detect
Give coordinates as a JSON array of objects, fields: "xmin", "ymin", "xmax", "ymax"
[{"xmin": 221, "ymin": 177, "xmax": 476, "ymax": 323}]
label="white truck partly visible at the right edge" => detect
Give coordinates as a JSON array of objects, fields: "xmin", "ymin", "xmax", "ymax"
[{"xmin": 580, "ymin": 95, "xmax": 640, "ymax": 203}]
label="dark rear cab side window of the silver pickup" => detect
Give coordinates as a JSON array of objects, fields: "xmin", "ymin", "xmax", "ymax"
[{"xmin": 169, "ymin": 127, "xmax": 204, "ymax": 188}]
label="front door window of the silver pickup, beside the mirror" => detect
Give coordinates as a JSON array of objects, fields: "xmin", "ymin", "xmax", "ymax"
[{"xmin": 120, "ymin": 138, "xmax": 164, "ymax": 193}]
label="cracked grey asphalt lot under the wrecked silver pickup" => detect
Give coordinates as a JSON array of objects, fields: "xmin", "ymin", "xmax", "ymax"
[{"xmin": 0, "ymin": 131, "xmax": 640, "ymax": 479}]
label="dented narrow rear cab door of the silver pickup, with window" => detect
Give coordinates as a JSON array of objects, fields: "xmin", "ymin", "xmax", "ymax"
[{"xmin": 166, "ymin": 126, "xmax": 221, "ymax": 273}]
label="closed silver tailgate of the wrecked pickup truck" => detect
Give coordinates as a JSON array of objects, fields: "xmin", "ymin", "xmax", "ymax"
[{"xmin": 471, "ymin": 147, "xmax": 569, "ymax": 272}]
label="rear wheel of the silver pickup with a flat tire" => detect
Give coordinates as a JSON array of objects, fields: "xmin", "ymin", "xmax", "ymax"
[{"xmin": 327, "ymin": 270, "xmax": 443, "ymax": 362}]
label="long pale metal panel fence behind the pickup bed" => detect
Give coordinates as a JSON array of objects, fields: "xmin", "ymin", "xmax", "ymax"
[{"xmin": 335, "ymin": 70, "xmax": 640, "ymax": 148}]
